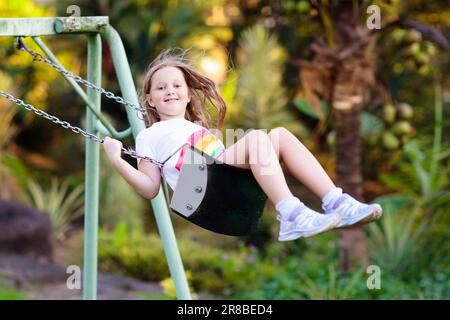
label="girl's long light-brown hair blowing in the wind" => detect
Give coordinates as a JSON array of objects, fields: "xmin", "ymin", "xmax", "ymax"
[{"xmin": 139, "ymin": 48, "xmax": 226, "ymax": 130}]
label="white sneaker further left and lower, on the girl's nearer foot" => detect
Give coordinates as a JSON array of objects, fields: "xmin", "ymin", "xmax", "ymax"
[{"xmin": 277, "ymin": 205, "xmax": 340, "ymax": 241}]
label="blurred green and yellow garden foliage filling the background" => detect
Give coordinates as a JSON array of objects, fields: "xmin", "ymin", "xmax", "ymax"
[{"xmin": 0, "ymin": 0, "xmax": 450, "ymax": 299}]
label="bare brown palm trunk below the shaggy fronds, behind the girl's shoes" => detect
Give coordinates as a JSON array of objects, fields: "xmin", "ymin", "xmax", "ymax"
[{"xmin": 334, "ymin": 94, "xmax": 368, "ymax": 272}]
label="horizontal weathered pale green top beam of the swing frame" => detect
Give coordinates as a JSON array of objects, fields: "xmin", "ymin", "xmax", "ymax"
[{"xmin": 0, "ymin": 16, "xmax": 109, "ymax": 36}]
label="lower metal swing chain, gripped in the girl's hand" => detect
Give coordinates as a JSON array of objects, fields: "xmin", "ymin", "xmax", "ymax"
[{"xmin": 0, "ymin": 90, "xmax": 164, "ymax": 168}]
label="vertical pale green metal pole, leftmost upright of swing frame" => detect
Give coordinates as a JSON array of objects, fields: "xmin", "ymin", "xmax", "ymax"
[{"xmin": 83, "ymin": 34, "xmax": 102, "ymax": 300}]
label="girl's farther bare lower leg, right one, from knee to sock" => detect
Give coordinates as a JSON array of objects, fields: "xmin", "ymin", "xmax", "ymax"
[{"xmin": 269, "ymin": 127, "xmax": 336, "ymax": 199}]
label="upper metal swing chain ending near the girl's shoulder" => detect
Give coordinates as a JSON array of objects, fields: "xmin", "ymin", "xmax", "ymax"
[{"xmin": 16, "ymin": 37, "xmax": 145, "ymax": 115}]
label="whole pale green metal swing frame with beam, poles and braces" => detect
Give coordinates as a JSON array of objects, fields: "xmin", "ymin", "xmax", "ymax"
[{"xmin": 0, "ymin": 16, "xmax": 192, "ymax": 300}]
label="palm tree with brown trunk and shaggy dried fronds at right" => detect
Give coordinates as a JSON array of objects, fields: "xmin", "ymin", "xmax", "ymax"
[{"xmin": 290, "ymin": 0, "xmax": 450, "ymax": 271}]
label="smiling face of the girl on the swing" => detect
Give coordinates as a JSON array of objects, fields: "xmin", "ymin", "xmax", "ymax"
[{"xmin": 147, "ymin": 67, "xmax": 191, "ymax": 120}]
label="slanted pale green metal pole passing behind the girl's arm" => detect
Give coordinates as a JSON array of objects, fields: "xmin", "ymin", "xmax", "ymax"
[{"xmin": 100, "ymin": 25, "xmax": 192, "ymax": 300}]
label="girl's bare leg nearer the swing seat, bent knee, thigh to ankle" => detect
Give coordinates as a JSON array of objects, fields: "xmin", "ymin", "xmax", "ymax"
[{"xmin": 218, "ymin": 130, "xmax": 293, "ymax": 205}]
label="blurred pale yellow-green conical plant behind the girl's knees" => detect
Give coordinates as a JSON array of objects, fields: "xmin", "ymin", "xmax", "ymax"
[{"xmin": 228, "ymin": 24, "xmax": 308, "ymax": 137}]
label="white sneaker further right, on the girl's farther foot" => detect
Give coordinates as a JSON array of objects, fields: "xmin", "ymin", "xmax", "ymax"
[{"xmin": 322, "ymin": 193, "xmax": 383, "ymax": 228}]
